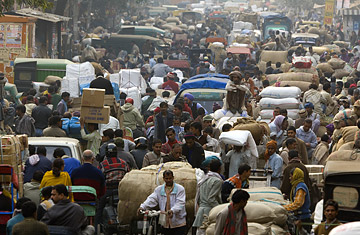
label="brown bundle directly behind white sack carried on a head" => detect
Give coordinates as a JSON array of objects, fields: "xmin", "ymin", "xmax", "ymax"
[{"xmin": 229, "ymin": 118, "xmax": 270, "ymax": 145}]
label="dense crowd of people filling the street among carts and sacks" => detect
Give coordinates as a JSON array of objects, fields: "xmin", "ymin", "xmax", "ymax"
[{"xmin": 3, "ymin": 1, "xmax": 360, "ymax": 235}]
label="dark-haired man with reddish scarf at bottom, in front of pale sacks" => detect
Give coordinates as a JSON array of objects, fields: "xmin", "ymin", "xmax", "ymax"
[{"xmin": 215, "ymin": 189, "xmax": 250, "ymax": 235}]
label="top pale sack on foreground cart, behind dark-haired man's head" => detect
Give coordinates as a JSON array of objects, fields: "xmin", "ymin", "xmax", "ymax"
[{"xmin": 230, "ymin": 187, "xmax": 286, "ymax": 203}]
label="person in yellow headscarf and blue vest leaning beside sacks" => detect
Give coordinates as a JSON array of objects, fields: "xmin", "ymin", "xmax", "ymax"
[{"xmin": 284, "ymin": 168, "xmax": 313, "ymax": 232}]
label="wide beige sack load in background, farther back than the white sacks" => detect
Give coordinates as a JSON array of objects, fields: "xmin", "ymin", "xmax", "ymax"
[{"xmin": 258, "ymin": 51, "xmax": 291, "ymax": 73}]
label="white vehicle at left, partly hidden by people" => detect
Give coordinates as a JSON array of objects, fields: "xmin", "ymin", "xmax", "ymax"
[{"xmin": 29, "ymin": 137, "xmax": 82, "ymax": 162}]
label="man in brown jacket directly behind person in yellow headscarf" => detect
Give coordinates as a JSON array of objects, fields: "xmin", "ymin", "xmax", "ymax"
[{"xmin": 280, "ymin": 150, "xmax": 311, "ymax": 198}]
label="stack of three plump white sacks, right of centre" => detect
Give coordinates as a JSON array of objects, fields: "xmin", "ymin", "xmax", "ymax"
[{"xmin": 260, "ymin": 87, "xmax": 301, "ymax": 123}]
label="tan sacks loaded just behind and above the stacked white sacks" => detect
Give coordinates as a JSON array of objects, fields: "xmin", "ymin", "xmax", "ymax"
[{"xmin": 275, "ymin": 73, "xmax": 319, "ymax": 92}]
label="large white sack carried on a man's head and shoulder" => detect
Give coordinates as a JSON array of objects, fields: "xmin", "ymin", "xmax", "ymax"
[{"xmin": 219, "ymin": 130, "xmax": 259, "ymax": 157}]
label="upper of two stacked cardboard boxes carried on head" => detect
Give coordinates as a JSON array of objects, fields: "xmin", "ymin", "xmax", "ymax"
[{"xmin": 81, "ymin": 88, "xmax": 105, "ymax": 108}]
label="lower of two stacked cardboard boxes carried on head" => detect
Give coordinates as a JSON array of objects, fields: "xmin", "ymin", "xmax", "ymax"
[{"xmin": 81, "ymin": 106, "xmax": 110, "ymax": 124}]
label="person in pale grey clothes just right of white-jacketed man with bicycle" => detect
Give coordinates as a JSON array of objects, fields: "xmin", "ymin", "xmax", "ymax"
[{"xmin": 193, "ymin": 159, "xmax": 223, "ymax": 232}]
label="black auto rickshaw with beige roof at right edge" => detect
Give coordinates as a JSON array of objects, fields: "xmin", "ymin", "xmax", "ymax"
[{"xmin": 324, "ymin": 161, "xmax": 360, "ymax": 222}]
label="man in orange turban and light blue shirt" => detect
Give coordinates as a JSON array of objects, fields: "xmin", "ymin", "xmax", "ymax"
[{"xmin": 264, "ymin": 140, "xmax": 283, "ymax": 189}]
